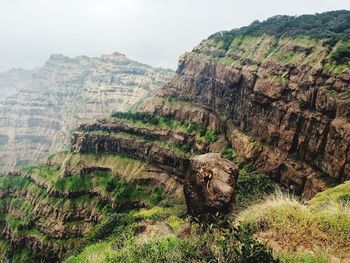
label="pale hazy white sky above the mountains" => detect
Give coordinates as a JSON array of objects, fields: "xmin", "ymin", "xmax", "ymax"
[{"xmin": 0, "ymin": 0, "xmax": 350, "ymax": 71}]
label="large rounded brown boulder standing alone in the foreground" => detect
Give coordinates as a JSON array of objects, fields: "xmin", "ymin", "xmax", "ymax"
[{"xmin": 184, "ymin": 153, "xmax": 238, "ymax": 217}]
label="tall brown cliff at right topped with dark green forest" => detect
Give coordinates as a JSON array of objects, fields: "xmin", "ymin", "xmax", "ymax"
[{"xmin": 160, "ymin": 11, "xmax": 350, "ymax": 197}]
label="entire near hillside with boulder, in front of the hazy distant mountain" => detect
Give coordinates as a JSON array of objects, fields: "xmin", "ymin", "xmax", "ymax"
[{"xmin": 0, "ymin": 11, "xmax": 350, "ymax": 263}]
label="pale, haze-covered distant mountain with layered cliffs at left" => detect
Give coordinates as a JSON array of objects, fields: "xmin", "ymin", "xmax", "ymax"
[{"xmin": 0, "ymin": 53, "xmax": 172, "ymax": 171}]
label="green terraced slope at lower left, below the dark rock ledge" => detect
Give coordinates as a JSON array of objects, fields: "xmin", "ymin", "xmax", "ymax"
[{"xmin": 0, "ymin": 153, "xmax": 183, "ymax": 262}]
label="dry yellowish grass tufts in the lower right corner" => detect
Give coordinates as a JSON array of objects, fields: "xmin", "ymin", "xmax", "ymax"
[{"xmin": 237, "ymin": 190, "xmax": 350, "ymax": 262}]
